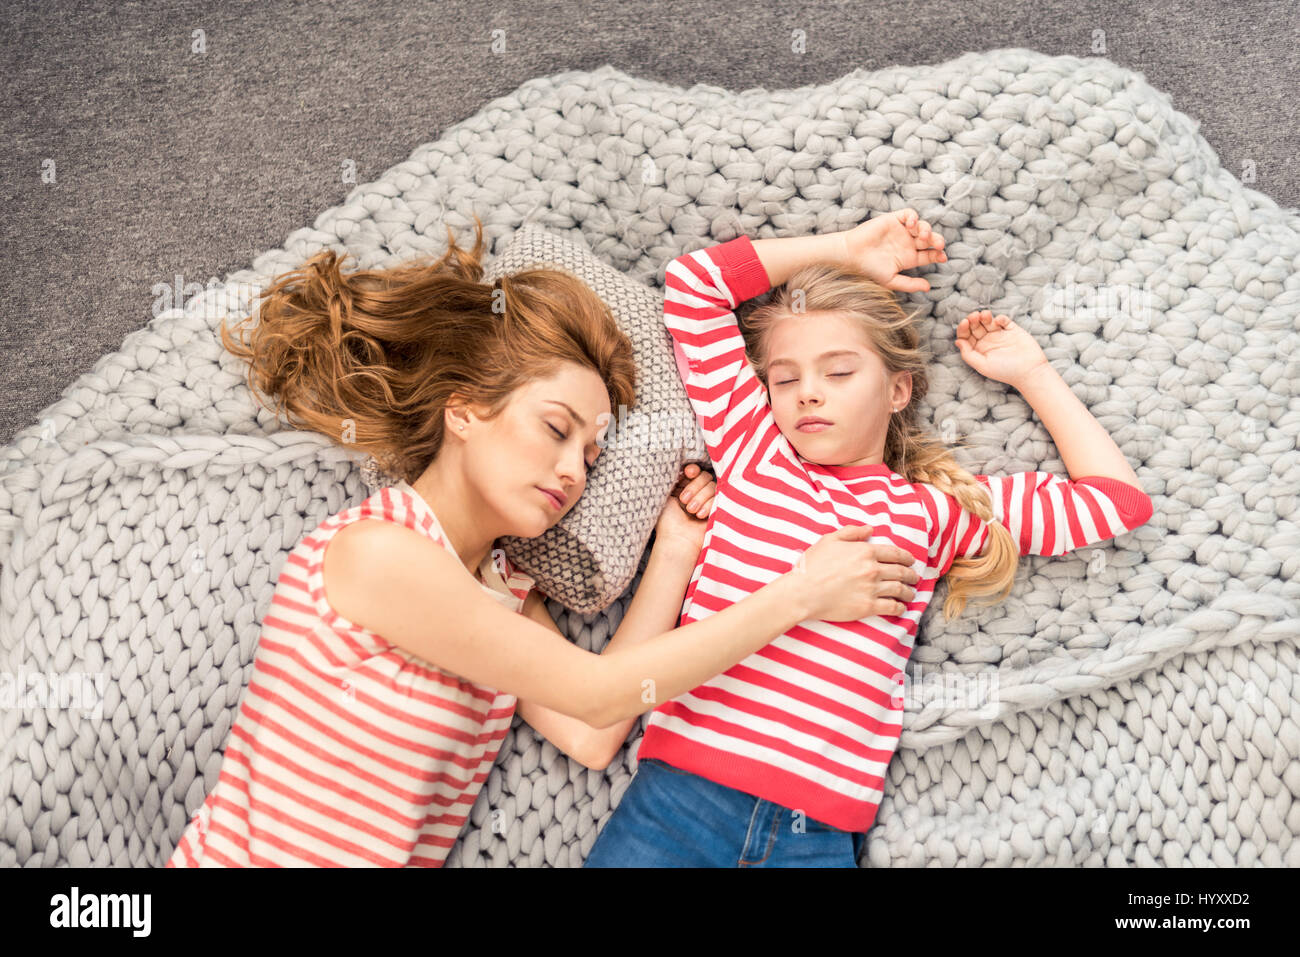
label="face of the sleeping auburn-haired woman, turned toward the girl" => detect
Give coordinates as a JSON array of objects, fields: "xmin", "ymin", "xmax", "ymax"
[{"xmin": 451, "ymin": 363, "xmax": 611, "ymax": 538}]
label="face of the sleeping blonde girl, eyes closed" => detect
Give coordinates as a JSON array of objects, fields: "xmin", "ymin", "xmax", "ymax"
[{"xmin": 767, "ymin": 312, "xmax": 911, "ymax": 465}]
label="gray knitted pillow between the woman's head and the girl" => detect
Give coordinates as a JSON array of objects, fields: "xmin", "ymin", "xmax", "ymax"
[{"xmin": 363, "ymin": 224, "xmax": 710, "ymax": 614}]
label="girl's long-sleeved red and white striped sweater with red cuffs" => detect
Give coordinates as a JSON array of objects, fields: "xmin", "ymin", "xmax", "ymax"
[{"xmin": 638, "ymin": 237, "xmax": 1152, "ymax": 831}]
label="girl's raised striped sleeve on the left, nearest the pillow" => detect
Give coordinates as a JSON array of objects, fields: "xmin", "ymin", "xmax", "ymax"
[{"xmin": 663, "ymin": 235, "xmax": 771, "ymax": 479}]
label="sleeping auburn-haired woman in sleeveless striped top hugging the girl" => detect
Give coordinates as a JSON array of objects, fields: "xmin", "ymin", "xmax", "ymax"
[{"xmin": 168, "ymin": 214, "xmax": 911, "ymax": 866}]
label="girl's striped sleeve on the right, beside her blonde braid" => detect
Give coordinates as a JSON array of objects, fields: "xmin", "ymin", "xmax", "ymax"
[{"xmin": 918, "ymin": 472, "xmax": 1153, "ymax": 575}]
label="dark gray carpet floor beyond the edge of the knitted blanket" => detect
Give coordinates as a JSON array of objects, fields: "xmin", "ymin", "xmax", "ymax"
[{"xmin": 0, "ymin": 0, "xmax": 1300, "ymax": 431}]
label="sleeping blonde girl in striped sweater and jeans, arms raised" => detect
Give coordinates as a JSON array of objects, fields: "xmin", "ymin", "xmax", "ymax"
[{"xmin": 586, "ymin": 209, "xmax": 1152, "ymax": 867}]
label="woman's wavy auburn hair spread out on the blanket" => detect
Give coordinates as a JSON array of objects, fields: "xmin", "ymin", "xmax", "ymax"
[{"xmin": 221, "ymin": 216, "xmax": 636, "ymax": 481}]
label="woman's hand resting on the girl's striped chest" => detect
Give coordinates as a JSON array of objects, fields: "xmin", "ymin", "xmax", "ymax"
[{"xmin": 787, "ymin": 525, "xmax": 920, "ymax": 622}]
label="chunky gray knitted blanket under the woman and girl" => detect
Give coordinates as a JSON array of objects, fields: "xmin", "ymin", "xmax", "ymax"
[{"xmin": 0, "ymin": 49, "xmax": 1300, "ymax": 866}]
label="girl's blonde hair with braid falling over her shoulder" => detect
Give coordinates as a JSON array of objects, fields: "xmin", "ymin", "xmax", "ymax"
[{"xmin": 742, "ymin": 263, "xmax": 1019, "ymax": 619}]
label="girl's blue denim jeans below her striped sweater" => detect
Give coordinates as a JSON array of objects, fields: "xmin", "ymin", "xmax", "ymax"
[{"xmin": 584, "ymin": 758, "xmax": 866, "ymax": 867}]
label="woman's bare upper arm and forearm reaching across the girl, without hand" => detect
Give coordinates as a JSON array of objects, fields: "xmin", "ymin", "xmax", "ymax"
[{"xmin": 322, "ymin": 520, "xmax": 811, "ymax": 733}]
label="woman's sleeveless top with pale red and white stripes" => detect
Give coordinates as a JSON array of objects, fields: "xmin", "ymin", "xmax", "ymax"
[{"xmin": 166, "ymin": 481, "xmax": 534, "ymax": 867}]
